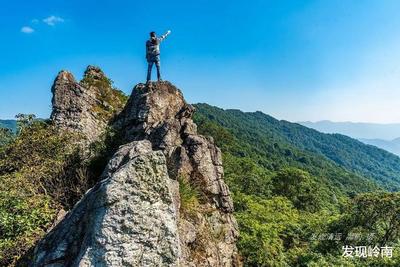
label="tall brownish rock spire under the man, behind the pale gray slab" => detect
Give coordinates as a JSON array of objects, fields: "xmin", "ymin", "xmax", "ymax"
[{"xmin": 116, "ymin": 82, "xmax": 240, "ymax": 266}]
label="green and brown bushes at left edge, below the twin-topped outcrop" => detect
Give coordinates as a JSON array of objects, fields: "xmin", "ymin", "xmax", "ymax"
[{"xmin": 0, "ymin": 115, "xmax": 85, "ymax": 266}]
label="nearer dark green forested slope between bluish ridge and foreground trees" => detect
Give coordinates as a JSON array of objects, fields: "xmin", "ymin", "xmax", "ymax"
[{"xmin": 195, "ymin": 104, "xmax": 379, "ymax": 200}]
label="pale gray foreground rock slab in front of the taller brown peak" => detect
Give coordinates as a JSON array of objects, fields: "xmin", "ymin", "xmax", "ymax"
[{"xmin": 33, "ymin": 141, "xmax": 180, "ymax": 267}]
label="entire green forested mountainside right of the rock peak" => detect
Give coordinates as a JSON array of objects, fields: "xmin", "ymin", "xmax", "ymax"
[{"xmin": 195, "ymin": 104, "xmax": 400, "ymax": 266}]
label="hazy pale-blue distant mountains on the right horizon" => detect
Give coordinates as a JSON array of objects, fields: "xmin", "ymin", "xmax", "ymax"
[{"xmin": 299, "ymin": 120, "xmax": 400, "ymax": 156}]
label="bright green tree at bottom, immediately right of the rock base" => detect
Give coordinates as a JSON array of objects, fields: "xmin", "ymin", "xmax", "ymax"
[{"xmin": 235, "ymin": 194, "xmax": 299, "ymax": 266}]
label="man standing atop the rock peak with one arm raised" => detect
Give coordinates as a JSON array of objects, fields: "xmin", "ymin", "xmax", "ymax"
[{"xmin": 146, "ymin": 31, "xmax": 171, "ymax": 83}]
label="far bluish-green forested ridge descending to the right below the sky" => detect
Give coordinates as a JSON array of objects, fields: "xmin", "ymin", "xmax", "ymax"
[{"xmin": 196, "ymin": 104, "xmax": 400, "ymax": 191}]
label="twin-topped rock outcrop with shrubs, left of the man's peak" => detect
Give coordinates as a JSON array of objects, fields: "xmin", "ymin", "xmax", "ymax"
[{"xmin": 50, "ymin": 66, "xmax": 125, "ymax": 144}]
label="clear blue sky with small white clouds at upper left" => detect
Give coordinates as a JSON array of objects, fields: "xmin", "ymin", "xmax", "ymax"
[{"xmin": 0, "ymin": 0, "xmax": 400, "ymax": 123}]
